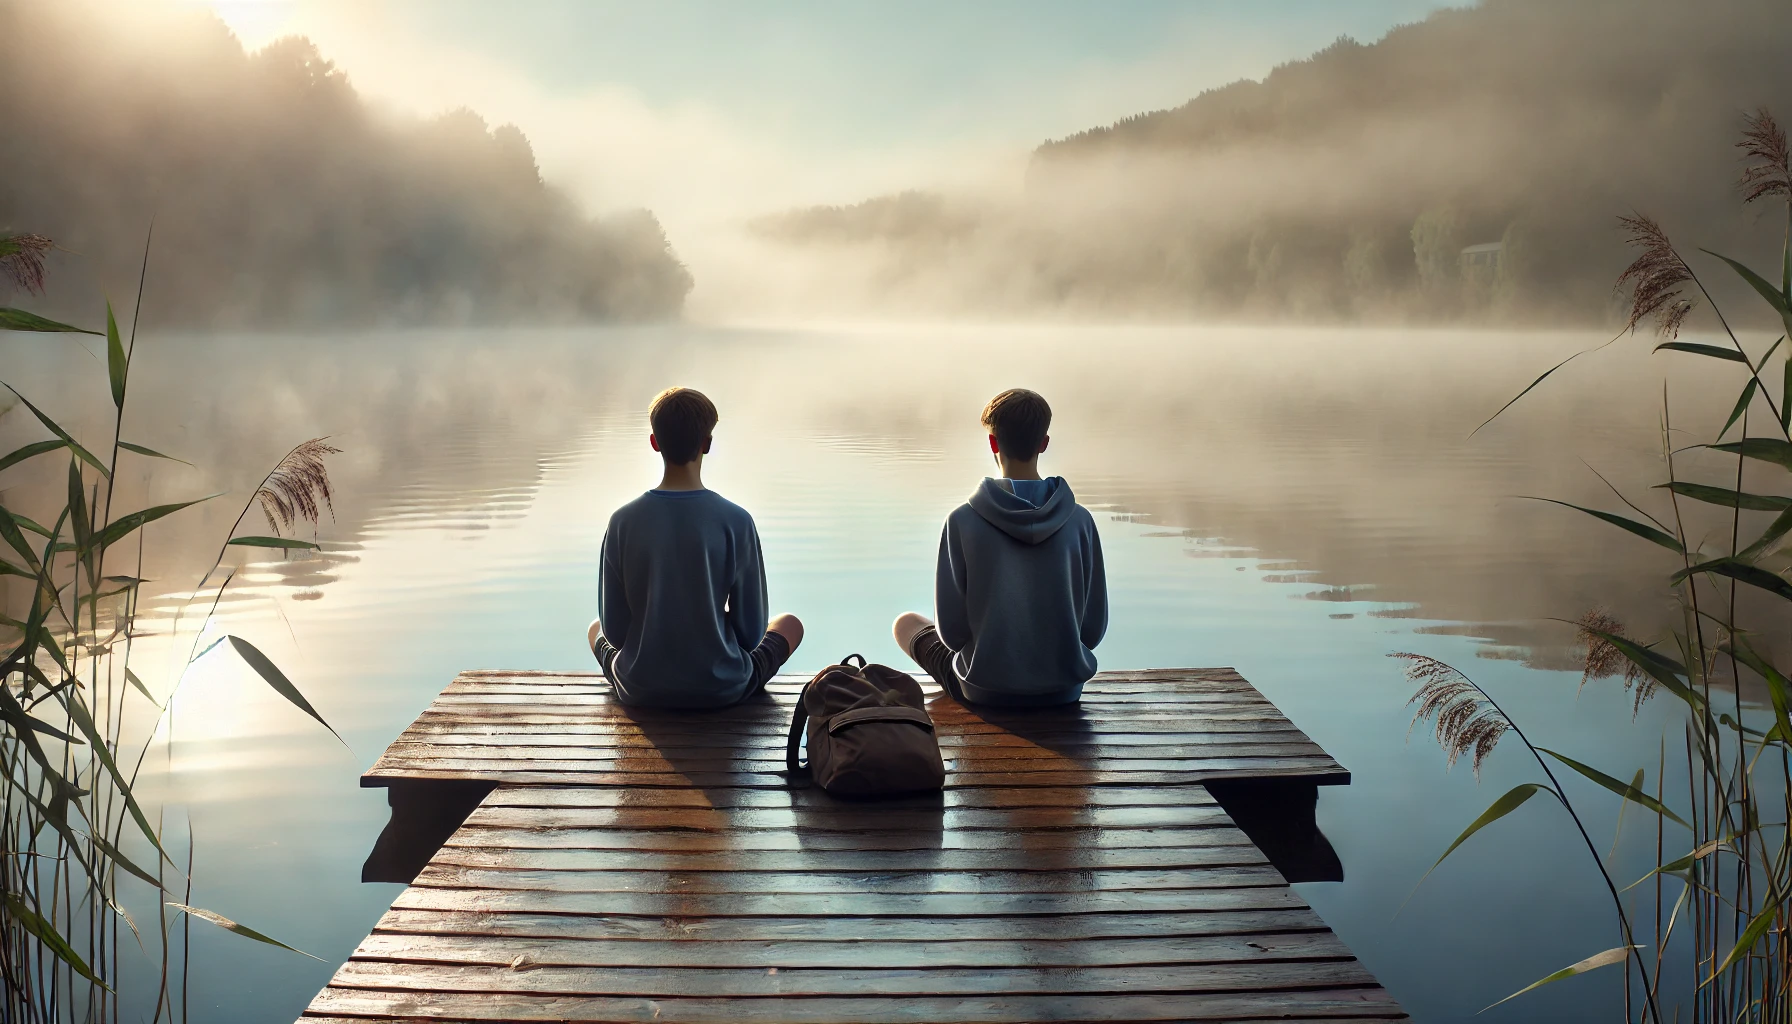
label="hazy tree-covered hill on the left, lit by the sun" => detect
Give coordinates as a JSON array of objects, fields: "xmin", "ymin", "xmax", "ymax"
[{"xmin": 0, "ymin": 0, "xmax": 692, "ymax": 326}]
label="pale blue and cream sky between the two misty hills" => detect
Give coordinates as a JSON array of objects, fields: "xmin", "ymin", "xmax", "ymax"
[{"xmin": 186, "ymin": 0, "xmax": 1446, "ymax": 308}]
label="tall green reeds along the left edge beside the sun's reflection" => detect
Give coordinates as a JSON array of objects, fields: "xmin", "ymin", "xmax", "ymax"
[{"xmin": 0, "ymin": 235, "xmax": 335, "ymax": 1024}]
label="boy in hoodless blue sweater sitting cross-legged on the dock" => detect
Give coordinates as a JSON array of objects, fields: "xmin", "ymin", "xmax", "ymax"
[{"xmin": 586, "ymin": 387, "xmax": 803, "ymax": 708}]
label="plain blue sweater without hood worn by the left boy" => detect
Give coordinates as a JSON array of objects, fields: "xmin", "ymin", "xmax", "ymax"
[{"xmin": 597, "ymin": 490, "xmax": 769, "ymax": 708}]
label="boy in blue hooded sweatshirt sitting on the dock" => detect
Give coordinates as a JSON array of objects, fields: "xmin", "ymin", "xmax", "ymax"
[{"xmin": 892, "ymin": 387, "xmax": 1107, "ymax": 707}]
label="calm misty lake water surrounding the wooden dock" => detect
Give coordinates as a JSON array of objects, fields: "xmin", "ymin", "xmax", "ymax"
[{"xmin": 0, "ymin": 326, "xmax": 1727, "ymax": 1022}]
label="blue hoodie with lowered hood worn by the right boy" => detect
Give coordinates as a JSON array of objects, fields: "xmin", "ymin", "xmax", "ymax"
[{"xmin": 934, "ymin": 477, "xmax": 1107, "ymax": 705}]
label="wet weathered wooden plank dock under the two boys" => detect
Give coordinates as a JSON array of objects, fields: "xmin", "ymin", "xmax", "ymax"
[{"xmin": 303, "ymin": 669, "xmax": 1405, "ymax": 1024}]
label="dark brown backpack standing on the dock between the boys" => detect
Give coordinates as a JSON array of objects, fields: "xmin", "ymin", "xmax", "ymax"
[{"xmin": 785, "ymin": 655, "xmax": 946, "ymax": 798}]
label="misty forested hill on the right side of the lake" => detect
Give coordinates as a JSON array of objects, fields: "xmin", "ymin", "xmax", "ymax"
[{"xmin": 760, "ymin": 0, "xmax": 1792, "ymax": 321}]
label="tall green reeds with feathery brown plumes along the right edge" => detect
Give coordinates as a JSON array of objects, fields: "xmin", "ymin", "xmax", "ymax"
[{"xmin": 1396, "ymin": 111, "xmax": 1792, "ymax": 1024}]
